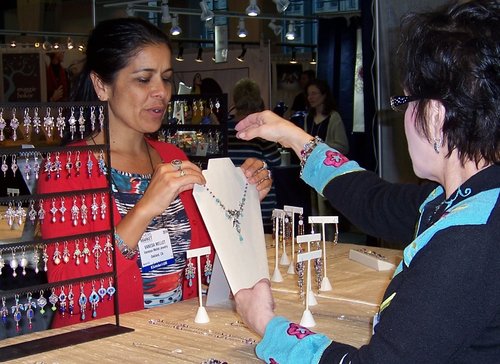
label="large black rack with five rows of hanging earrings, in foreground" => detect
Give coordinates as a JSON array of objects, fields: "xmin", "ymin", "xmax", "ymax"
[{"xmin": 0, "ymin": 102, "xmax": 132, "ymax": 360}]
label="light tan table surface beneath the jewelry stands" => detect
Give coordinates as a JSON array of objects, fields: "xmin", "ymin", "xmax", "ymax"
[{"xmin": 0, "ymin": 236, "xmax": 401, "ymax": 363}]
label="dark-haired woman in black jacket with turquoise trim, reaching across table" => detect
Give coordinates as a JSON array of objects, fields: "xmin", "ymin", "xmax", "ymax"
[{"xmin": 235, "ymin": 0, "xmax": 500, "ymax": 364}]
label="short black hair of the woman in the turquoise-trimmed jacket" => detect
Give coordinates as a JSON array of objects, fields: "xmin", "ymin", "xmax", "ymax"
[{"xmin": 398, "ymin": 0, "xmax": 500, "ymax": 165}]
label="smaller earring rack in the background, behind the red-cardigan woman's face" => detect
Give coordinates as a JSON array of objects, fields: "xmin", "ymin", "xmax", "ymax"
[{"xmin": 158, "ymin": 94, "xmax": 228, "ymax": 168}]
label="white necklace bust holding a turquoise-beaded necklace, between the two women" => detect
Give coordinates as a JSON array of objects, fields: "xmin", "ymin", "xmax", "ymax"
[{"xmin": 193, "ymin": 158, "xmax": 269, "ymax": 293}]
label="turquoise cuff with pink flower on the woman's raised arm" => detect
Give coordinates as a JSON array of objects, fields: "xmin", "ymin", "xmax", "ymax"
[{"xmin": 301, "ymin": 143, "xmax": 364, "ymax": 195}]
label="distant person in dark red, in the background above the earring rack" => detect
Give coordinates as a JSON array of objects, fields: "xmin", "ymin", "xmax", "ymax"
[{"xmin": 46, "ymin": 52, "xmax": 70, "ymax": 102}]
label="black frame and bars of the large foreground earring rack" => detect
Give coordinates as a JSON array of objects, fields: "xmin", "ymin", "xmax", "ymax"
[{"xmin": 0, "ymin": 102, "xmax": 133, "ymax": 361}]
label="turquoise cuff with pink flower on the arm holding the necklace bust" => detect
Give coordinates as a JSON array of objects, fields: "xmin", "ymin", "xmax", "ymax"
[{"xmin": 255, "ymin": 316, "xmax": 332, "ymax": 364}]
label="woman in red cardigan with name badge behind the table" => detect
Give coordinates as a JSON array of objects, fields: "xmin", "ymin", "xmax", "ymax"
[{"xmin": 38, "ymin": 17, "xmax": 271, "ymax": 327}]
